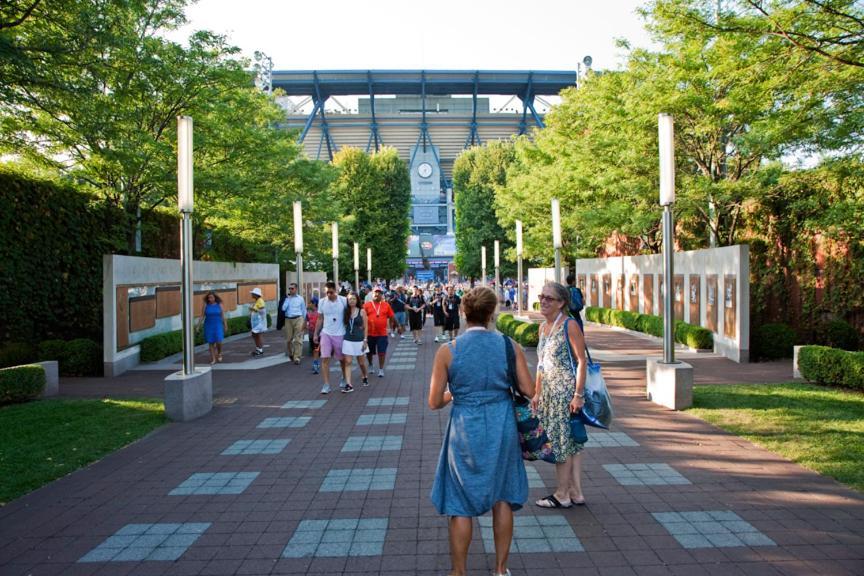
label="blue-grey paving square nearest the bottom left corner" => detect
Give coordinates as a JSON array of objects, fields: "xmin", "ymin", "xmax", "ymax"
[{"xmin": 78, "ymin": 522, "xmax": 210, "ymax": 562}]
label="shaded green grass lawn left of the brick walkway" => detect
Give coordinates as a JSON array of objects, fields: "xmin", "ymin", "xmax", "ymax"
[{"xmin": 0, "ymin": 398, "xmax": 165, "ymax": 506}]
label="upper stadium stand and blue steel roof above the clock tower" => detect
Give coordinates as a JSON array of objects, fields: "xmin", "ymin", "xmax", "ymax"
[{"xmin": 272, "ymin": 70, "xmax": 577, "ymax": 176}]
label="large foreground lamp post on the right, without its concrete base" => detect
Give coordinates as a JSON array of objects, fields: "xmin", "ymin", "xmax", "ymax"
[{"xmin": 658, "ymin": 114, "xmax": 675, "ymax": 364}]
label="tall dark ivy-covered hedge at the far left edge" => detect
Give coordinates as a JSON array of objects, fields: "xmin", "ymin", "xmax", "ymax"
[{"xmin": 0, "ymin": 168, "xmax": 118, "ymax": 343}]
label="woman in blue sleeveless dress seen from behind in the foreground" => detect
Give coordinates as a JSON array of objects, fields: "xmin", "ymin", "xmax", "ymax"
[{"xmin": 429, "ymin": 288, "xmax": 534, "ymax": 576}]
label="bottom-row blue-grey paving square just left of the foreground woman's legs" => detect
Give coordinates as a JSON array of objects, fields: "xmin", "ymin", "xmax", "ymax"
[{"xmin": 282, "ymin": 518, "xmax": 388, "ymax": 558}]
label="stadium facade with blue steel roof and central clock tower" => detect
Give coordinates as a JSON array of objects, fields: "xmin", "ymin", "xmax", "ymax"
[{"xmin": 272, "ymin": 70, "xmax": 576, "ymax": 280}]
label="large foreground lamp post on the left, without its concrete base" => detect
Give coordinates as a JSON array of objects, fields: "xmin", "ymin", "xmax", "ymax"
[{"xmin": 177, "ymin": 116, "xmax": 195, "ymax": 376}]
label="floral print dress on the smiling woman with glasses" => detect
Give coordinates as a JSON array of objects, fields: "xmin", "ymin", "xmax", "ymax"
[{"xmin": 537, "ymin": 322, "xmax": 585, "ymax": 463}]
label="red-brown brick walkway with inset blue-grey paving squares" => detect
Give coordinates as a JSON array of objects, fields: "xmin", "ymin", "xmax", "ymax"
[{"xmin": 0, "ymin": 326, "xmax": 864, "ymax": 576}]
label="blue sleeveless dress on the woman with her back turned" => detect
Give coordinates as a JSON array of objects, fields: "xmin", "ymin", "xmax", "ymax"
[{"xmin": 429, "ymin": 330, "xmax": 528, "ymax": 516}]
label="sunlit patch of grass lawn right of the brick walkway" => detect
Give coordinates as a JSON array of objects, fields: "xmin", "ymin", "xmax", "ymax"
[{"xmin": 689, "ymin": 382, "xmax": 864, "ymax": 491}]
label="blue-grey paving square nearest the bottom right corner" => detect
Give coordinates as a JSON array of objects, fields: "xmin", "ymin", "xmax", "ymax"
[{"xmin": 652, "ymin": 510, "xmax": 776, "ymax": 548}]
